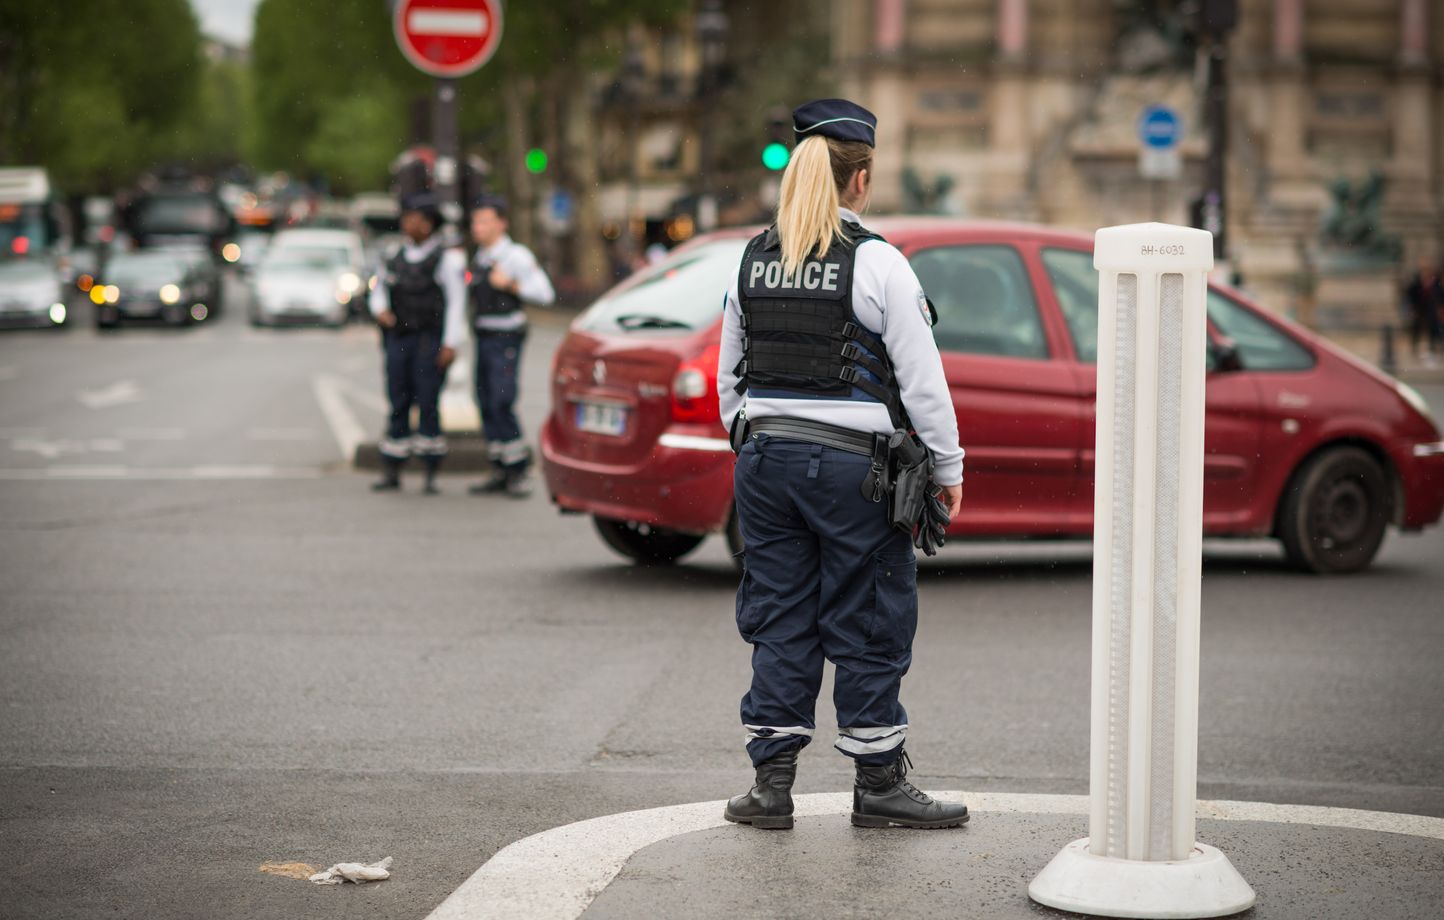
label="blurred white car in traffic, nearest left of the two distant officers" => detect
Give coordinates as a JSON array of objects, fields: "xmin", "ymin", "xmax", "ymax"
[{"xmin": 251, "ymin": 230, "xmax": 367, "ymax": 326}]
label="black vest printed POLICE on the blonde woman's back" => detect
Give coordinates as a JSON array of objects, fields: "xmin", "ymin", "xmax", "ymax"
[{"xmin": 735, "ymin": 221, "xmax": 904, "ymax": 425}]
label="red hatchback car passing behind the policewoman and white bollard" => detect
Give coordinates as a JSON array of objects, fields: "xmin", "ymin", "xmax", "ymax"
[{"xmin": 542, "ymin": 217, "xmax": 1444, "ymax": 572}]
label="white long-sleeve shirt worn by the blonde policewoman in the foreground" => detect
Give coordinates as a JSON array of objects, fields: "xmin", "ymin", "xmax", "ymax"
[{"xmin": 718, "ymin": 208, "xmax": 963, "ymax": 485}]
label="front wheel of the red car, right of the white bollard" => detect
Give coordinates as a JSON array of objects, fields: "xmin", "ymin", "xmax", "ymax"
[{"xmin": 1278, "ymin": 448, "xmax": 1393, "ymax": 575}]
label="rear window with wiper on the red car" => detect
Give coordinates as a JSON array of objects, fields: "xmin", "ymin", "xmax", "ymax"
[{"xmin": 579, "ymin": 238, "xmax": 747, "ymax": 332}]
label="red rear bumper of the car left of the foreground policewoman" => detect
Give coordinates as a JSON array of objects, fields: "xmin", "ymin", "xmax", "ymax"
[{"xmin": 542, "ymin": 416, "xmax": 734, "ymax": 533}]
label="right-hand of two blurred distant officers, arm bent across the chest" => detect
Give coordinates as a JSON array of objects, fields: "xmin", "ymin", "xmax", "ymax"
[{"xmin": 468, "ymin": 195, "xmax": 556, "ymax": 498}]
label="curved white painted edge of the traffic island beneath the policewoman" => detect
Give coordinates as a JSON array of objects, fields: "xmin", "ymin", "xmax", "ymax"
[{"xmin": 427, "ymin": 791, "xmax": 1444, "ymax": 920}]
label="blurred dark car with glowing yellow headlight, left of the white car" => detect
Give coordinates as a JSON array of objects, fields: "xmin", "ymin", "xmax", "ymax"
[{"xmin": 90, "ymin": 250, "xmax": 208, "ymax": 328}]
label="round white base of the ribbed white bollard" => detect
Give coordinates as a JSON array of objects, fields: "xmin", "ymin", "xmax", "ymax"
[{"xmin": 1028, "ymin": 838, "xmax": 1253, "ymax": 920}]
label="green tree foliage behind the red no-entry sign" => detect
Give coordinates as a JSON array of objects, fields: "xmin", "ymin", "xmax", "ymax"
[{"xmin": 251, "ymin": 0, "xmax": 689, "ymax": 191}]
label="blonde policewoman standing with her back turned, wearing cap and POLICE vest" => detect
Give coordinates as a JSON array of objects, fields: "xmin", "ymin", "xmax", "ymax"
[{"xmin": 718, "ymin": 100, "xmax": 967, "ymax": 828}]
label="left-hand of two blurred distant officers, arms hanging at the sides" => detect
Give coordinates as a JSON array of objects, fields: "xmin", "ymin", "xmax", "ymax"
[{"xmin": 371, "ymin": 192, "xmax": 466, "ymax": 495}]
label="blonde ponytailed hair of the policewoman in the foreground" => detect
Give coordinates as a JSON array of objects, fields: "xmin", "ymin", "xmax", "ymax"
[{"xmin": 777, "ymin": 134, "xmax": 872, "ymax": 273}]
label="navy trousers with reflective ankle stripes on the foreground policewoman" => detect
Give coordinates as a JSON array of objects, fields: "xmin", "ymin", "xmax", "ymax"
[{"xmin": 734, "ymin": 435, "xmax": 917, "ymax": 764}]
